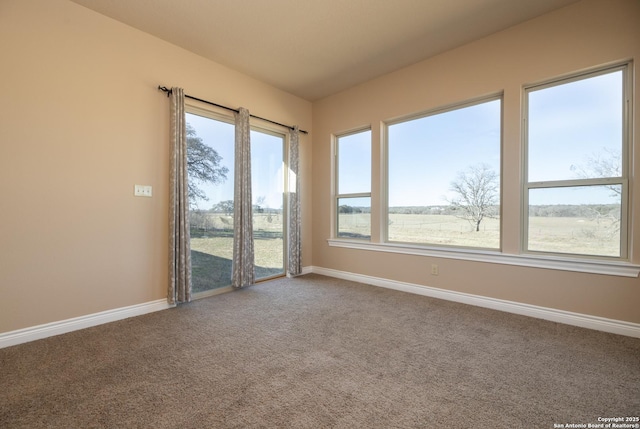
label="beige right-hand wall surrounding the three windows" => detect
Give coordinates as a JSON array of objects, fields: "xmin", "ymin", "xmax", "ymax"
[{"xmin": 313, "ymin": 0, "xmax": 640, "ymax": 323}]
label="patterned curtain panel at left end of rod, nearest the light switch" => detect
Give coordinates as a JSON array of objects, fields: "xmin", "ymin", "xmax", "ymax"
[{"xmin": 167, "ymin": 88, "xmax": 191, "ymax": 305}]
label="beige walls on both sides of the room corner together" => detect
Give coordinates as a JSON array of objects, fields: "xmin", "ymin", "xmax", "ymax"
[{"xmin": 0, "ymin": 0, "xmax": 640, "ymax": 333}]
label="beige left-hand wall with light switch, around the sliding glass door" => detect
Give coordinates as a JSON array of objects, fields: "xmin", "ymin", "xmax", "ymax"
[{"xmin": 0, "ymin": 0, "xmax": 312, "ymax": 333}]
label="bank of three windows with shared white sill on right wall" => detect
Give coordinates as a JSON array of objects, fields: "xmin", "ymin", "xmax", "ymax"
[{"xmin": 328, "ymin": 63, "xmax": 640, "ymax": 277}]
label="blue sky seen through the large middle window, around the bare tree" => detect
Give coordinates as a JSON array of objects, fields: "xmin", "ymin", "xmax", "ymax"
[{"xmin": 388, "ymin": 100, "xmax": 501, "ymax": 207}]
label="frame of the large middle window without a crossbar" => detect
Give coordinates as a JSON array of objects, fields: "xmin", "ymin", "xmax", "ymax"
[{"xmin": 381, "ymin": 91, "xmax": 504, "ymax": 249}]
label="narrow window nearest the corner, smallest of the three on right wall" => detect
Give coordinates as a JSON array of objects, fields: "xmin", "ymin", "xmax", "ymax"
[{"xmin": 335, "ymin": 130, "xmax": 371, "ymax": 240}]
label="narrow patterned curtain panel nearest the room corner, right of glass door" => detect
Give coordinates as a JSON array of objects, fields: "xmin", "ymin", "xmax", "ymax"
[{"xmin": 287, "ymin": 126, "xmax": 302, "ymax": 277}]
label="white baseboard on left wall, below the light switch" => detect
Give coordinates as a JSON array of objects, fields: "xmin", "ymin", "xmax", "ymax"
[{"xmin": 0, "ymin": 299, "xmax": 171, "ymax": 349}]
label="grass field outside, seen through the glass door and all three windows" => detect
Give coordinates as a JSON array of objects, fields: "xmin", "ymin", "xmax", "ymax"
[{"xmin": 191, "ymin": 213, "xmax": 620, "ymax": 292}]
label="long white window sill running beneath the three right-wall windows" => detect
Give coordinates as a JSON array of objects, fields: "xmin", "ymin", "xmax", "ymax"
[{"xmin": 327, "ymin": 239, "xmax": 640, "ymax": 277}]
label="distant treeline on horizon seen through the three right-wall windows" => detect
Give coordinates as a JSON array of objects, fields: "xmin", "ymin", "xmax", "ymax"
[{"xmin": 338, "ymin": 204, "xmax": 620, "ymax": 217}]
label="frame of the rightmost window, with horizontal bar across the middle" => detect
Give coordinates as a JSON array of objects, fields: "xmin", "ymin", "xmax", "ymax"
[{"xmin": 520, "ymin": 62, "xmax": 632, "ymax": 261}]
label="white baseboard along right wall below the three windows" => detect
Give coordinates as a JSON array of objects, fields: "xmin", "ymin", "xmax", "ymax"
[{"xmin": 311, "ymin": 266, "xmax": 640, "ymax": 338}]
